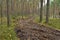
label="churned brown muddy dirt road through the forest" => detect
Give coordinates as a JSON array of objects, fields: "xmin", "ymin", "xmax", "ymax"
[{"xmin": 15, "ymin": 20, "xmax": 60, "ymax": 40}]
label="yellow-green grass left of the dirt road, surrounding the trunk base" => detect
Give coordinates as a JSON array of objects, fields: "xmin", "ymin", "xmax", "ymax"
[{"xmin": 0, "ymin": 17, "xmax": 18, "ymax": 40}]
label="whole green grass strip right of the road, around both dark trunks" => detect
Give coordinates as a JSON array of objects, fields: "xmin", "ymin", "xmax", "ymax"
[{"xmin": 34, "ymin": 17, "xmax": 60, "ymax": 29}]
